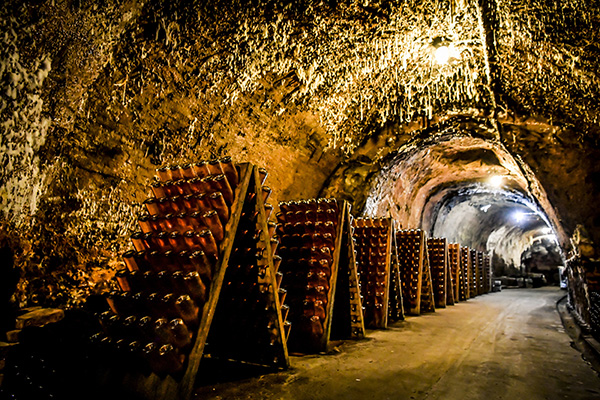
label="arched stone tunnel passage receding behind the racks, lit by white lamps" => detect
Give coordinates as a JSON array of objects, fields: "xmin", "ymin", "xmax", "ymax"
[{"xmin": 342, "ymin": 130, "xmax": 564, "ymax": 283}]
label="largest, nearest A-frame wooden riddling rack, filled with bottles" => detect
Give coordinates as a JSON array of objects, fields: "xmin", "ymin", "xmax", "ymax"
[{"xmin": 93, "ymin": 157, "xmax": 289, "ymax": 400}]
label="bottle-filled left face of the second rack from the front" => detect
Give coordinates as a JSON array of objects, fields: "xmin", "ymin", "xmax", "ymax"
[{"xmin": 277, "ymin": 199, "xmax": 340, "ymax": 351}]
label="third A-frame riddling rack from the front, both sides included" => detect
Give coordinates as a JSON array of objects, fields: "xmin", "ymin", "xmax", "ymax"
[{"xmin": 352, "ymin": 218, "xmax": 404, "ymax": 328}]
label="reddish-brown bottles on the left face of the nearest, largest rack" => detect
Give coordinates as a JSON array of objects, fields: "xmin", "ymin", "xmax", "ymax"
[{"xmin": 94, "ymin": 157, "xmax": 239, "ymax": 375}]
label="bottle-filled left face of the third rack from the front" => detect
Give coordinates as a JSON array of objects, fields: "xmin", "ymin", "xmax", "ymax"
[{"xmin": 354, "ymin": 218, "xmax": 391, "ymax": 328}]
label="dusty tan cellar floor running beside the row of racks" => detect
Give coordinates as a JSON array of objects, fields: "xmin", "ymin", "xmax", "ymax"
[{"xmin": 195, "ymin": 287, "xmax": 600, "ymax": 400}]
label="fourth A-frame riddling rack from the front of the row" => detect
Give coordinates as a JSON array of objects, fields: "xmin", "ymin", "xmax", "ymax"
[{"xmin": 396, "ymin": 229, "xmax": 435, "ymax": 315}]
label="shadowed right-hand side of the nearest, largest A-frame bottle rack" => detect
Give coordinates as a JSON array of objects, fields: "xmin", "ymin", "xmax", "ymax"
[{"xmin": 206, "ymin": 168, "xmax": 291, "ymax": 367}]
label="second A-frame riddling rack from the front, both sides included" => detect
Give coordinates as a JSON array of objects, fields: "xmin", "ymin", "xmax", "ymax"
[{"xmin": 277, "ymin": 199, "xmax": 365, "ymax": 353}]
